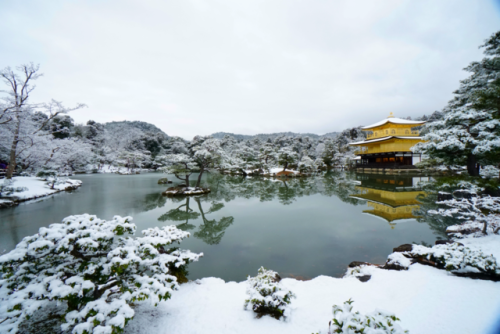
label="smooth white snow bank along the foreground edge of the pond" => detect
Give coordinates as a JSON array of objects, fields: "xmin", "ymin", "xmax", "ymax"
[{"xmin": 125, "ymin": 264, "xmax": 500, "ymax": 334}]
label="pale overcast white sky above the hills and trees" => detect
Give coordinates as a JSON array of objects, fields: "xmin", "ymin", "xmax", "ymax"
[{"xmin": 0, "ymin": 0, "xmax": 500, "ymax": 139}]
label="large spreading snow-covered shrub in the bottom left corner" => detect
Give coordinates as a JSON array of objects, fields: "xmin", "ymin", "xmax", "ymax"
[{"xmin": 0, "ymin": 214, "xmax": 203, "ymax": 334}]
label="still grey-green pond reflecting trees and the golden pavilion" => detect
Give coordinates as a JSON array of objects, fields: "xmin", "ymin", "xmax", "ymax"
[{"xmin": 0, "ymin": 172, "xmax": 454, "ymax": 281}]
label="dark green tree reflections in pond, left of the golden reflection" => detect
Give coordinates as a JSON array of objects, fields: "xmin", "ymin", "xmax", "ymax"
[{"xmin": 143, "ymin": 172, "xmax": 364, "ymax": 245}]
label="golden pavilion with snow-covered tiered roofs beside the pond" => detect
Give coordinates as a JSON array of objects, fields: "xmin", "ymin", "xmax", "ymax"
[{"xmin": 349, "ymin": 112, "xmax": 425, "ymax": 169}]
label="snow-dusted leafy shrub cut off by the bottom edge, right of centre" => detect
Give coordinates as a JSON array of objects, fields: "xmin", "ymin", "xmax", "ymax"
[{"xmin": 328, "ymin": 299, "xmax": 408, "ymax": 334}]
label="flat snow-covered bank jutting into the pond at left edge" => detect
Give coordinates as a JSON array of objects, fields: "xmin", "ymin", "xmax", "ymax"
[{"xmin": 0, "ymin": 176, "xmax": 82, "ymax": 202}]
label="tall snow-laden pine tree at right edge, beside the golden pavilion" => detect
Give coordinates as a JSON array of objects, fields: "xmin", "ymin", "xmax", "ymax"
[{"xmin": 414, "ymin": 31, "xmax": 500, "ymax": 176}]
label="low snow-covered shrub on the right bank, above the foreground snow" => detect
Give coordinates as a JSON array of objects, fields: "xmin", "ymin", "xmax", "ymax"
[{"xmin": 405, "ymin": 243, "xmax": 500, "ymax": 275}]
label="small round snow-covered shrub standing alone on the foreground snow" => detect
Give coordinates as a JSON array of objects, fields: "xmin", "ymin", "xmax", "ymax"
[{"xmin": 245, "ymin": 267, "xmax": 295, "ymax": 319}]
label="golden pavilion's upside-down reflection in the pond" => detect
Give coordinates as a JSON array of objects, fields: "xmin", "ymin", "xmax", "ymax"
[{"xmin": 351, "ymin": 174, "xmax": 429, "ymax": 228}]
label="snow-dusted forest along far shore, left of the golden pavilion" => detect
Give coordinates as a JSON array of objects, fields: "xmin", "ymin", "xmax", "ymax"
[{"xmin": 0, "ymin": 64, "xmax": 374, "ymax": 178}]
